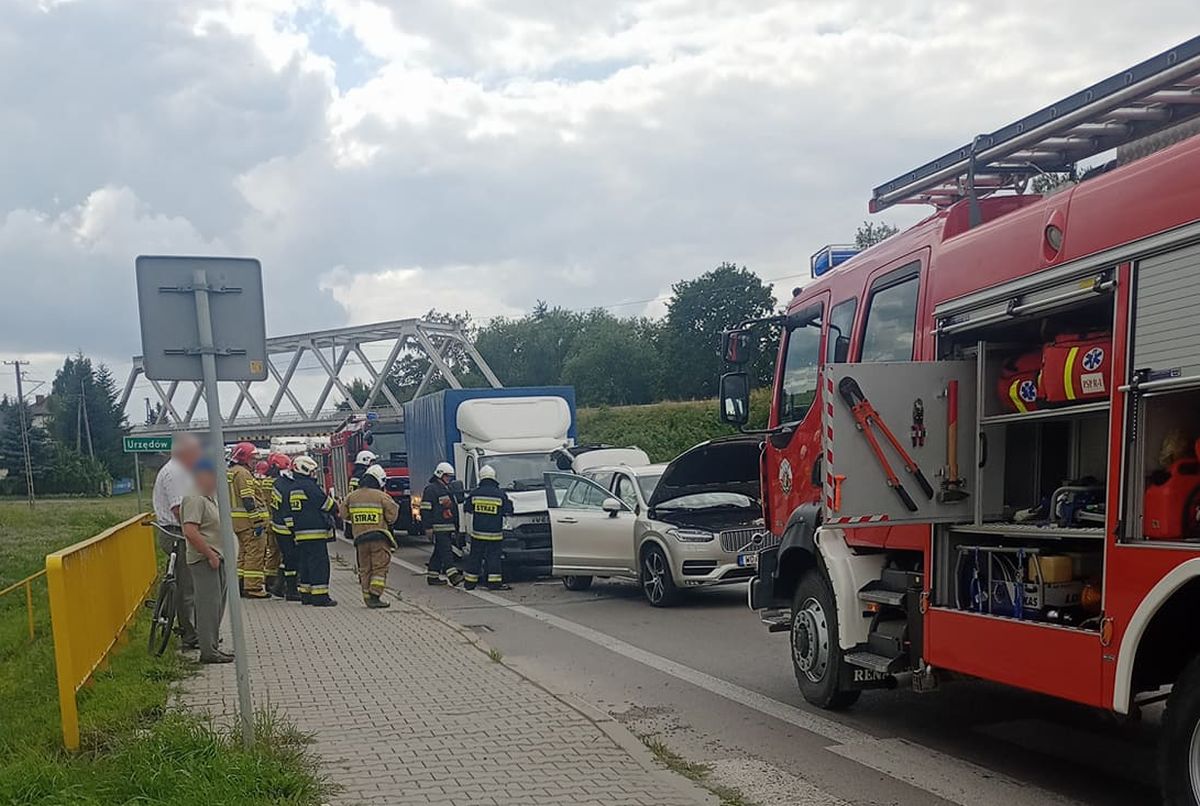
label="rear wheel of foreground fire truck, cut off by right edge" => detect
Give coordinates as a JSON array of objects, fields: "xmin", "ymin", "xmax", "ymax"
[{"xmin": 1158, "ymin": 657, "xmax": 1200, "ymax": 806}]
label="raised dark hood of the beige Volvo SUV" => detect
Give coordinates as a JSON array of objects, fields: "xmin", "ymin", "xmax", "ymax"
[{"xmin": 647, "ymin": 437, "xmax": 762, "ymax": 509}]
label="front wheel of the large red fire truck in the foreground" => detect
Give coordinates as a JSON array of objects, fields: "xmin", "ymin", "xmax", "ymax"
[{"xmin": 790, "ymin": 569, "xmax": 863, "ymax": 711}]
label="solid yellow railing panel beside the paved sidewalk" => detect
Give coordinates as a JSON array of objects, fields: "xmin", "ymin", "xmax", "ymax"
[{"xmin": 46, "ymin": 515, "xmax": 158, "ymax": 750}]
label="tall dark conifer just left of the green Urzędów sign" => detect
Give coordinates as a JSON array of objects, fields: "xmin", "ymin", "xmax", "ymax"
[{"xmin": 49, "ymin": 353, "xmax": 133, "ymax": 475}]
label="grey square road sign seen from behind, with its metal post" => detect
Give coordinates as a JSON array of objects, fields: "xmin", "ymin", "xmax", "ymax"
[{"xmin": 136, "ymin": 255, "xmax": 266, "ymax": 745}]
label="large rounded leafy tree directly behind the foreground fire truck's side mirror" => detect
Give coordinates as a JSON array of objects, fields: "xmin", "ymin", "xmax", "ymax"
[{"xmin": 660, "ymin": 263, "xmax": 775, "ymax": 399}]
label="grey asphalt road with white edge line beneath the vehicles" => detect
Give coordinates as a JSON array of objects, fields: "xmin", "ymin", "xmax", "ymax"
[{"xmin": 389, "ymin": 534, "xmax": 1159, "ymax": 806}]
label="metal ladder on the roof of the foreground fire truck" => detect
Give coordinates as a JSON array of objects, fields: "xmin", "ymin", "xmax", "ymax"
[{"xmin": 870, "ymin": 36, "xmax": 1200, "ymax": 217}]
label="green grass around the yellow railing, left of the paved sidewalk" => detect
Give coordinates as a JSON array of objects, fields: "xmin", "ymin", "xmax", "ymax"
[{"xmin": 0, "ymin": 497, "xmax": 323, "ymax": 806}]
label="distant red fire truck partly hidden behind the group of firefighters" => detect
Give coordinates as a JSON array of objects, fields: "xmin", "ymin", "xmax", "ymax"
[{"xmin": 324, "ymin": 413, "xmax": 421, "ymax": 535}]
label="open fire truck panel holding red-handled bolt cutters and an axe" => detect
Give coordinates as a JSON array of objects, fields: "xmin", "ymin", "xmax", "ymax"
[{"xmin": 821, "ymin": 361, "xmax": 979, "ymax": 525}]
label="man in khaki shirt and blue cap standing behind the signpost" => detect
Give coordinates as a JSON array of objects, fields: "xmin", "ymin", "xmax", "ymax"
[{"xmin": 182, "ymin": 458, "xmax": 233, "ymax": 663}]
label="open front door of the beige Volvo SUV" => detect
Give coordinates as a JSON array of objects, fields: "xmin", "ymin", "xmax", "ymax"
[{"xmin": 546, "ymin": 473, "xmax": 636, "ymax": 576}]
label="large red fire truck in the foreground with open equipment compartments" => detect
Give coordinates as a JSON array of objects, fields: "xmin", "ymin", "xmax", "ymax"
[{"xmin": 720, "ymin": 37, "xmax": 1200, "ymax": 805}]
